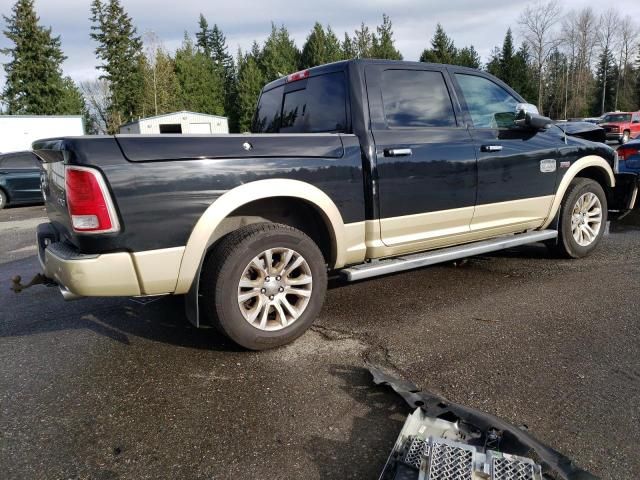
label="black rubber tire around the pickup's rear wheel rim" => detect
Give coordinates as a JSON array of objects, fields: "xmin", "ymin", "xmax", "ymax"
[{"xmin": 200, "ymin": 223, "xmax": 327, "ymax": 350}]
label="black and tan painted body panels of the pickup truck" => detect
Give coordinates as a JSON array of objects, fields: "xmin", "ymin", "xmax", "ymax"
[{"xmin": 34, "ymin": 61, "xmax": 628, "ymax": 295}]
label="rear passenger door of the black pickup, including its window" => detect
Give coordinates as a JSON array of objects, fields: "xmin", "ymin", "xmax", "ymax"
[{"xmin": 366, "ymin": 64, "xmax": 476, "ymax": 253}]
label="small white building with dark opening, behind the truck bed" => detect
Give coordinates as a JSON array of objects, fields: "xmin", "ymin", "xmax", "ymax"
[{"xmin": 120, "ymin": 112, "xmax": 229, "ymax": 134}]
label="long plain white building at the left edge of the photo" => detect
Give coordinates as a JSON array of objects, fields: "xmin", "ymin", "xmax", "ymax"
[{"xmin": 0, "ymin": 115, "xmax": 84, "ymax": 153}]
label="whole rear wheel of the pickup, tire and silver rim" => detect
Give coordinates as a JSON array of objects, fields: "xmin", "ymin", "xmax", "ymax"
[{"xmin": 200, "ymin": 223, "xmax": 327, "ymax": 350}]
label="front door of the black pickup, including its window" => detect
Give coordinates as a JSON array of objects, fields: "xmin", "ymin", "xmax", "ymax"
[{"xmin": 451, "ymin": 69, "xmax": 563, "ymax": 233}]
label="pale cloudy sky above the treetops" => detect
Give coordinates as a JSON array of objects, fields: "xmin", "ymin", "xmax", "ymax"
[{"xmin": 0, "ymin": 0, "xmax": 640, "ymax": 84}]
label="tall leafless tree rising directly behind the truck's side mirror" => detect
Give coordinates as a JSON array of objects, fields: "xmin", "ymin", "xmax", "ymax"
[{"xmin": 518, "ymin": 0, "xmax": 562, "ymax": 113}]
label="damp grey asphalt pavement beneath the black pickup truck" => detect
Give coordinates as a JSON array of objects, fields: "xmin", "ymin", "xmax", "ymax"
[{"xmin": 0, "ymin": 206, "xmax": 640, "ymax": 479}]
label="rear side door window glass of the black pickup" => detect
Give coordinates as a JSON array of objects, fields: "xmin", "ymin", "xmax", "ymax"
[{"xmin": 382, "ymin": 70, "xmax": 456, "ymax": 128}]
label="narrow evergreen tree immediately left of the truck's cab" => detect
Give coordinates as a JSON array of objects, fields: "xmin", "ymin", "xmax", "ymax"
[{"xmin": 236, "ymin": 43, "xmax": 265, "ymax": 132}]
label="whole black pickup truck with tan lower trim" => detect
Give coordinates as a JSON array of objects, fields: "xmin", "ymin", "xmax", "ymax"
[{"xmin": 34, "ymin": 60, "xmax": 637, "ymax": 349}]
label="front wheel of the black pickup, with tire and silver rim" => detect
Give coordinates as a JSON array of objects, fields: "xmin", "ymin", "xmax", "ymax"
[{"xmin": 553, "ymin": 177, "xmax": 607, "ymax": 258}]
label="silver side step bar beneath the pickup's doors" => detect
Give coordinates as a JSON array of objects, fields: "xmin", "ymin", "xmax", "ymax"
[{"xmin": 340, "ymin": 230, "xmax": 558, "ymax": 282}]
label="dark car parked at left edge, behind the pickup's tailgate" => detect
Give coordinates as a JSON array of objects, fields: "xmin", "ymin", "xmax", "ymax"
[{"xmin": 0, "ymin": 152, "xmax": 43, "ymax": 210}]
